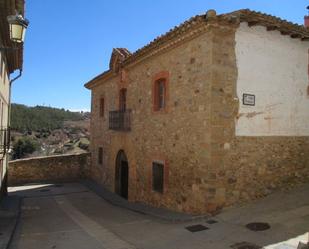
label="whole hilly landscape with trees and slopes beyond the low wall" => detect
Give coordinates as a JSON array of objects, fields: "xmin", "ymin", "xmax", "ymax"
[{"xmin": 11, "ymin": 104, "xmax": 90, "ymax": 159}]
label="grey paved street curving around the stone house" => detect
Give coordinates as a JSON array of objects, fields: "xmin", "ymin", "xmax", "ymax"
[{"xmin": 6, "ymin": 183, "xmax": 309, "ymax": 249}]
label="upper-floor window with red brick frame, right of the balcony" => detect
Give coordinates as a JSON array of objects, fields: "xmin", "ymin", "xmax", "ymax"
[{"xmin": 152, "ymin": 71, "xmax": 169, "ymax": 111}]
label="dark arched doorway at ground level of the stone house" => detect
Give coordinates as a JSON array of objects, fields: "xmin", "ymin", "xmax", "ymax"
[{"xmin": 115, "ymin": 150, "xmax": 129, "ymax": 199}]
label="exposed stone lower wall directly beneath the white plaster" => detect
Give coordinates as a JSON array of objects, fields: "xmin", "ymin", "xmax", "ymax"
[{"xmin": 223, "ymin": 136, "xmax": 309, "ymax": 205}]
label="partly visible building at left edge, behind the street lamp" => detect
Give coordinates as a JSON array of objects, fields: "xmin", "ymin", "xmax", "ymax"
[{"xmin": 0, "ymin": 0, "xmax": 25, "ymax": 200}]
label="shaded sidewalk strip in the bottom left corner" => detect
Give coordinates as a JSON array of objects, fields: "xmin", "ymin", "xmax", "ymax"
[{"xmin": 0, "ymin": 196, "xmax": 21, "ymax": 249}]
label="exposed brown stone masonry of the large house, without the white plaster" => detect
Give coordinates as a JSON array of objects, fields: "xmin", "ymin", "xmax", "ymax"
[{"xmin": 86, "ymin": 11, "xmax": 309, "ymax": 214}]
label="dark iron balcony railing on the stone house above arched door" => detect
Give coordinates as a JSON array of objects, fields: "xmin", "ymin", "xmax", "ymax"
[{"xmin": 109, "ymin": 110, "xmax": 131, "ymax": 131}]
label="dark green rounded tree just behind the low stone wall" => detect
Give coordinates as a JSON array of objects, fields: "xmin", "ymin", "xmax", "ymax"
[{"xmin": 12, "ymin": 137, "xmax": 39, "ymax": 160}]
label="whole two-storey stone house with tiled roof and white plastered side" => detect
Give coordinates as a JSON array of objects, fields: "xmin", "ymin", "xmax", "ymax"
[{"xmin": 85, "ymin": 9, "xmax": 309, "ymax": 214}]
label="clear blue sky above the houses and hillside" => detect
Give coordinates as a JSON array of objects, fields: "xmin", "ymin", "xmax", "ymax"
[{"xmin": 12, "ymin": 0, "xmax": 309, "ymax": 111}]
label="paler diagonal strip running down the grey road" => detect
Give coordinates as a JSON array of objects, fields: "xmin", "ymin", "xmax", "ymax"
[{"xmin": 54, "ymin": 196, "xmax": 136, "ymax": 249}]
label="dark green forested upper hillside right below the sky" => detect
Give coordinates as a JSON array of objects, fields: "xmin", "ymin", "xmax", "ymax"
[{"xmin": 11, "ymin": 104, "xmax": 89, "ymax": 132}]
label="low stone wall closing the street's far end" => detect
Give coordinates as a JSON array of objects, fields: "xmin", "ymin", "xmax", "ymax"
[{"xmin": 8, "ymin": 153, "xmax": 90, "ymax": 186}]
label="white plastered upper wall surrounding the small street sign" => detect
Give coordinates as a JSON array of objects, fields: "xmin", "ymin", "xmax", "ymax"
[{"xmin": 235, "ymin": 23, "xmax": 309, "ymax": 136}]
